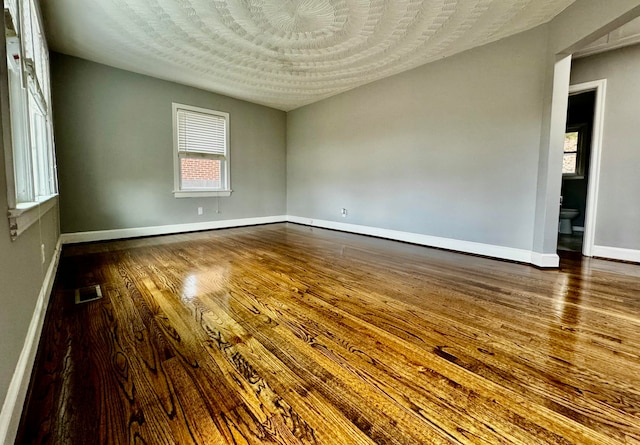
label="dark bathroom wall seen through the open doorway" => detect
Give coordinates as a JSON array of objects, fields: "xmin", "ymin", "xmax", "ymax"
[{"xmin": 562, "ymin": 91, "xmax": 596, "ymax": 227}]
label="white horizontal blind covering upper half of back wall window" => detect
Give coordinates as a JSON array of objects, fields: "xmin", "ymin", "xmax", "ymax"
[{"xmin": 177, "ymin": 108, "xmax": 227, "ymax": 159}]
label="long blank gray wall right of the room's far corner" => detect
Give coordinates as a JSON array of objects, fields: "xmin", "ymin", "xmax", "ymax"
[{"xmin": 287, "ymin": 27, "xmax": 547, "ymax": 249}]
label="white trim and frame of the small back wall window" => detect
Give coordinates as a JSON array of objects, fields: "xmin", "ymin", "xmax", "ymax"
[{"xmin": 172, "ymin": 102, "xmax": 232, "ymax": 198}]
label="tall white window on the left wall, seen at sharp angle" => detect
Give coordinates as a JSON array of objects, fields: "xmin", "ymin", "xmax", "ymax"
[{"xmin": 3, "ymin": 0, "xmax": 58, "ymax": 239}]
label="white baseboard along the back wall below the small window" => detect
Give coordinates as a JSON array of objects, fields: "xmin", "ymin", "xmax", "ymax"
[{"xmin": 61, "ymin": 215, "xmax": 287, "ymax": 244}]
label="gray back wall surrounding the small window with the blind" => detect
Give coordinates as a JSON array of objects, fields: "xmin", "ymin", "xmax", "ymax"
[{"xmin": 51, "ymin": 53, "xmax": 286, "ymax": 233}]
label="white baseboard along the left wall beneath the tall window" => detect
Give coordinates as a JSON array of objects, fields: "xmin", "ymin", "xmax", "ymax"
[{"xmin": 0, "ymin": 239, "xmax": 62, "ymax": 445}]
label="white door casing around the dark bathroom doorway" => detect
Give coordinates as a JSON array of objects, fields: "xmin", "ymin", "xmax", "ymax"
[{"xmin": 569, "ymin": 79, "xmax": 607, "ymax": 256}]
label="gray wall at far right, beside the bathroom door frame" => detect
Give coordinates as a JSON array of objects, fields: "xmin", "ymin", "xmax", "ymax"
[{"xmin": 571, "ymin": 45, "xmax": 640, "ymax": 250}]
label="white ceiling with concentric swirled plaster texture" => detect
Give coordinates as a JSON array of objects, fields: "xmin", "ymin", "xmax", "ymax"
[{"xmin": 42, "ymin": 0, "xmax": 574, "ymax": 110}]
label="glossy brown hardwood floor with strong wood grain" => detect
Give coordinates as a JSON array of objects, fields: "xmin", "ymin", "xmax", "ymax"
[{"xmin": 17, "ymin": 224, "xmax": 640, "ymax": 445}]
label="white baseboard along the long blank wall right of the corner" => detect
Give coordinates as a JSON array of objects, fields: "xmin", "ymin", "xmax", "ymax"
[{"xmin": 287, "ymin": 215, "xmax": 560, "ymax": 267}]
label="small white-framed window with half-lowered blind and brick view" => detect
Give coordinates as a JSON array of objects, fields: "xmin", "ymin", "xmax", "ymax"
[{"xmin": 173, "ymin": 103, "xmax": 231, "ymax": 198}]
